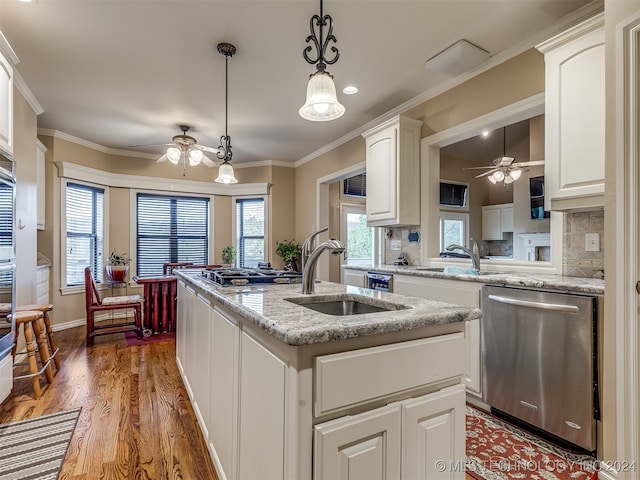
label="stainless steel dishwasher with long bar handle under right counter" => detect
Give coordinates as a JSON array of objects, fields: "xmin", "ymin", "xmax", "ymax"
[{"xmin": 482, "ymin": 286, "xmax": 599, "ymax": 452}]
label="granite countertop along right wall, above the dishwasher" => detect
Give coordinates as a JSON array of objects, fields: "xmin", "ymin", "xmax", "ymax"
[{"xmin": 342, "ymin": 265, "xmax": 604, "ymax": 295}]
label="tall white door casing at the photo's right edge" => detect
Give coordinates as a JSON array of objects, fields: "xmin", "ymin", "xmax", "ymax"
[{"xmin": 616, "ymin": 14, "xmax": 640, "ymax": 480}]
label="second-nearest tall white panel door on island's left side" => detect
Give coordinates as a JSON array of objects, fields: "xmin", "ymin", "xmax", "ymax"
[{"xmin": 209, "ymin": 308, "xmax": 240, "ymax": 480}]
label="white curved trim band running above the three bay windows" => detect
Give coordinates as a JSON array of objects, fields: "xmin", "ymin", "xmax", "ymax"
[{"xmin": 55, "ymin": 162, "xmax": 270, "ymax": 197}]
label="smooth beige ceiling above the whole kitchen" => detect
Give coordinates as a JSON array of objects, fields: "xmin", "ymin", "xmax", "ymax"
[{"xmin": 0, "ymin": 0, "xmax": 597, "ymax": 164}]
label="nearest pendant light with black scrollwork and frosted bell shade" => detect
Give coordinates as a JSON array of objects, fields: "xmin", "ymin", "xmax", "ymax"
[{"xmin": 299, "ymin": 0, "xmax": 344, "ymax": 122}]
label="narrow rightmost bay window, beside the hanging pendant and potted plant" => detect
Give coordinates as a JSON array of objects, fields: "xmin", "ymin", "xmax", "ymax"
[{"xmin": 236, "ymin": 198, "xmax": 265, "ymax": 267}]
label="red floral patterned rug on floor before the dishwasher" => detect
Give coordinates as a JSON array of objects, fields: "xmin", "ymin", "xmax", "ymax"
[{"xmin": 466, "ymin": 405, "xmax": 597, "ymax": 480}]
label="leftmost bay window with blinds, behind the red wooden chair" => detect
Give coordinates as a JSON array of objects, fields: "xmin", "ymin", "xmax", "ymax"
[{"xmin": 65, "ymin": 183, "xmax": 104, "ymax": 286}]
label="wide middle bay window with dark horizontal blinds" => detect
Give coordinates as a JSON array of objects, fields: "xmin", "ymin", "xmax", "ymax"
[{"xmin": 136, "ymin": 193, "xmax": 209, "ymax": 277}]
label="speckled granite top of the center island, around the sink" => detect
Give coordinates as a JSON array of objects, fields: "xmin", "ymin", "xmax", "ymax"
[{"xmin": 174, "ymin": 270, "xmax": 481, "ymax": 346}]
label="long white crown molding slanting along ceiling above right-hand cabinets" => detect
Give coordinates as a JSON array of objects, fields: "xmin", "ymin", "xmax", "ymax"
[{"xmin": 294, "ymin": 0, "xmax": 604, "ymax": 167}]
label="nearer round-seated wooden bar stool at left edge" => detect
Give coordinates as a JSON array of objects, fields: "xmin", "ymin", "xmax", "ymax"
[{"xmin": 12, "ymin": 310, "xmax": 53, "ymax": 400}]
